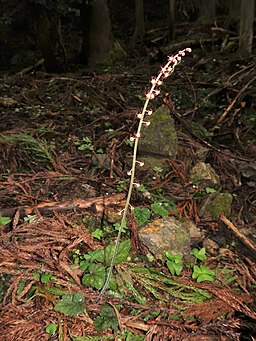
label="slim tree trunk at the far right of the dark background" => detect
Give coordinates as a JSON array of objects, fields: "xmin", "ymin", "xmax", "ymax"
[{"xmin": 238, "ymin": 0, "xmax": 254, "ymax": 58}]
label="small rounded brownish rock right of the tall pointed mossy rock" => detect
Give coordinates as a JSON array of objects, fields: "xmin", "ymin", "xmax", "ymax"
[{"xmin": 190, "ymin": 162, "xmax": 220, "ymax": 188}]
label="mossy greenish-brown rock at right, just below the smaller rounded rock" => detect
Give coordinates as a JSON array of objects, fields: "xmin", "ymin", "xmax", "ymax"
[{"xmin": 199, "ymin": 192, "xmax": 233, "ymax": 221}]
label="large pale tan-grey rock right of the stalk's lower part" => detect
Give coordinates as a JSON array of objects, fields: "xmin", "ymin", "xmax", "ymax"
[{"xmin": 138, "ymin": 217, "xmax": 191, "ymax": 259}]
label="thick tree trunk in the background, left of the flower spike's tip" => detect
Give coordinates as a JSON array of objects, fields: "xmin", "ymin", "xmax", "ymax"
[{"xmin": 84, "ymin": 0, "xmax": 112, "ymax": 65}]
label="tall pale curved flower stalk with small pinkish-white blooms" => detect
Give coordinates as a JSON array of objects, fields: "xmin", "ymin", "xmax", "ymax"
[{"xmin": 98, "ymin": 48, "xmax": 192, "ymax": 301}]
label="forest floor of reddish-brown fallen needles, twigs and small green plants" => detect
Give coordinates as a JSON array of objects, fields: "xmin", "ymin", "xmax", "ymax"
[{"xmin": 0, "ymin": 35, "xmax": 256, "ymax": 341}]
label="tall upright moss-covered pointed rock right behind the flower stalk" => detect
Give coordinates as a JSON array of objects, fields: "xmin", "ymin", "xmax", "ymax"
[{"xmin": 138, "ymin": 105, "xmax": 178, "ymax": 169}]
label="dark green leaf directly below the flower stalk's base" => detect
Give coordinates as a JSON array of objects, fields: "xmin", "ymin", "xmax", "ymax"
[{"xmin": 94, "ymin": 304, "xmax": 118, "ymax": 332}]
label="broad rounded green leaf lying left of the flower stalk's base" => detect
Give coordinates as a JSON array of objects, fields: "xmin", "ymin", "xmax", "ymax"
[{"xmin": 54, "ymin": 292, "xmax": 85, "ymax": 316}]
